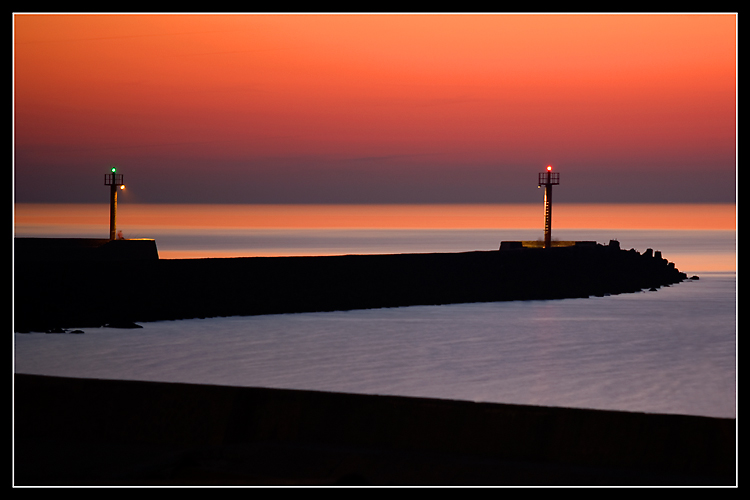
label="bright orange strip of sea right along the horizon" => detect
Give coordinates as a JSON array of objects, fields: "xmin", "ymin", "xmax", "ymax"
[{"xmin": 14, "ymin": 204, "xmax": 737, "ymax": 232}]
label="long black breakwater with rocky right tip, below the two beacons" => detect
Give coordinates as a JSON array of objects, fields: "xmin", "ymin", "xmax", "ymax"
[{"xmin": 15, "ymin": 245, "xmax": 685, "ymax": 331}]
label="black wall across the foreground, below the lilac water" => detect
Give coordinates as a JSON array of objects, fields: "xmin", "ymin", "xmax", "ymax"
[{"xmin": 14, "ymin": 374, "xmax": 736, "ymax": 485}]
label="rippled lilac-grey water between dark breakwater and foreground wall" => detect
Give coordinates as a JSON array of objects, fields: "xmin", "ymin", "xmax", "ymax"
[{"xmin": 15, "ymin": 256, "xmax": 737, "ymax": 417}]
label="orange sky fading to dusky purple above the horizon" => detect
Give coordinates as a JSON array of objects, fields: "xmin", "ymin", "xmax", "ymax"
[{"xmin": 14, "ymin": 14, "xmax": 737, "ymax": 203}]
